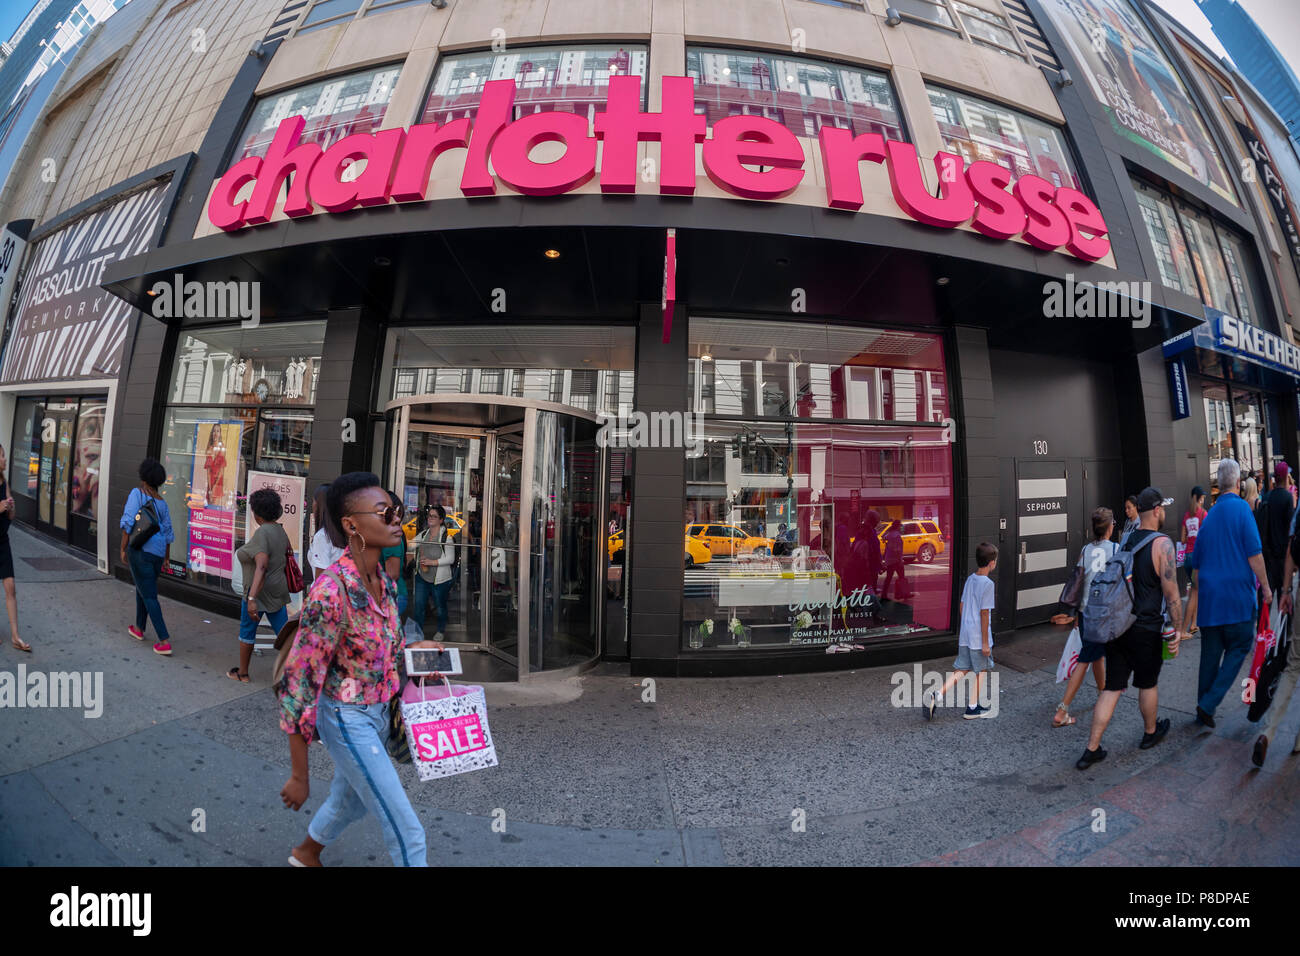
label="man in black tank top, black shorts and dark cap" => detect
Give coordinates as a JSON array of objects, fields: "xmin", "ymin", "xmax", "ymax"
[{"xmin": 1075, "ymin": 488, "xmax": 1183, "ymax": 770}]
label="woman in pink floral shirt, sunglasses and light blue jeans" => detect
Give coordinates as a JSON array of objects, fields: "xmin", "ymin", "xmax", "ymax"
[{"xmin": 276, "ymin": 472, "xmax": 441, "ymax": 866}]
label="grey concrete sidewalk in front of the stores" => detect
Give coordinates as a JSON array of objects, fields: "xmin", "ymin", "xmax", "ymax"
[{"xmin": 0, "ymin": 527, "xmax": 1300, "ymax": 866}]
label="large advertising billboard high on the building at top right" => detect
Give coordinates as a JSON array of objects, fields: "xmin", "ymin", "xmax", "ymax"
[{"xmin": 1041, "ymin": 0, "xmax": 1236, "ymax": 203}]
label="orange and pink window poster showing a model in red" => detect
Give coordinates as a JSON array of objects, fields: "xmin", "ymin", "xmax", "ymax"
[{"xmin": 189, "ymin": 421, "xmax": 243, "ymax": 579}]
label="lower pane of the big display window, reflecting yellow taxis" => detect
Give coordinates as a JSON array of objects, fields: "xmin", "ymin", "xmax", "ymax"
[{"xmin": 683, "ymin": 419, "xmax": 953, "ymax": 648}]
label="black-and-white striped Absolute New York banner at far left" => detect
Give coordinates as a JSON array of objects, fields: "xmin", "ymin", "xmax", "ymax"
[{"xmin": 0, "ymin": 183, "xmax": 166, "ymax": 384}]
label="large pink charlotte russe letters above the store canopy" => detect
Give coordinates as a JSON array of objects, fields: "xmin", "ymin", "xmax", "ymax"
[{"xmin": 208, "ymin": 75, "xmax": 1110, "ymax": 260}]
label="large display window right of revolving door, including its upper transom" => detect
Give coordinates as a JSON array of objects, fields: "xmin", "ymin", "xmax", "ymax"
[{"xmin": 681, "ymin": 319, "xmax": 954, "ymax": 650}]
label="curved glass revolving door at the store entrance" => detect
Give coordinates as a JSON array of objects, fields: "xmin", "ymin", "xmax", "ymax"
[{"xmin": 385, "ymin": 394, "xmax": 606, "ymax": 680}]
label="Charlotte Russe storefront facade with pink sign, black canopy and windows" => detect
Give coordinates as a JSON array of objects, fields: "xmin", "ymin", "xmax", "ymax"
[{"xmin": 0, "ymin": 0, "xmax": 1295, "ymax": 679}]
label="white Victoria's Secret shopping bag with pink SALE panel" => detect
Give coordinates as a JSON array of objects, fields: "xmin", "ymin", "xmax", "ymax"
[{"xmin": 402, "ymin": 678, "xmax": 497, "ymax": 780}]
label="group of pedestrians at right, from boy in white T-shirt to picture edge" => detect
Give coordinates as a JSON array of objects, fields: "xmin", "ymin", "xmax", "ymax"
[{"xmin": 922, "ymin": 459, "xmax": 1300, "ymax": 770}]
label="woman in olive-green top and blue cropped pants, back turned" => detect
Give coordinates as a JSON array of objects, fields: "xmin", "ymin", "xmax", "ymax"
[{"xmin": 226, "ymin": 488, "xmax": 293, "ymax": 684}]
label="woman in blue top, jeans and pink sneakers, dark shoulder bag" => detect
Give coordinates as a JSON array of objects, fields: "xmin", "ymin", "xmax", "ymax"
[{"xmin": 118, "ymin": 458, "xmax": 176, "ymax": 657}]
